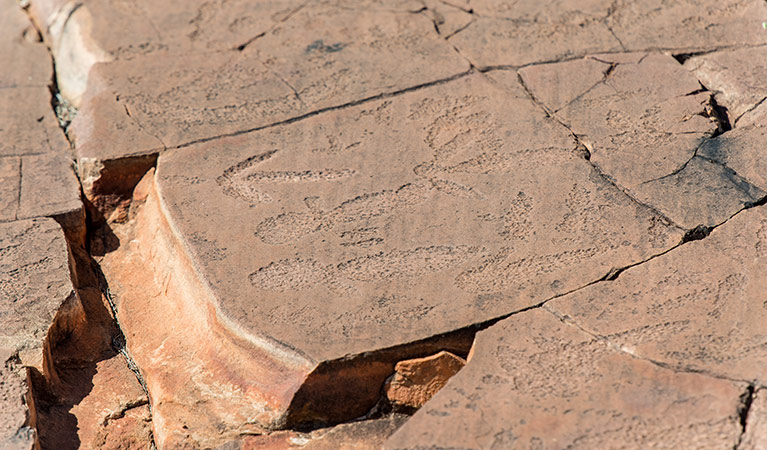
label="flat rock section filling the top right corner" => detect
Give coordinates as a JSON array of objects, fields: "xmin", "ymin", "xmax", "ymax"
[{"xmin": 607, "ymin": 0, "xmax": 767, "ymax": 52}]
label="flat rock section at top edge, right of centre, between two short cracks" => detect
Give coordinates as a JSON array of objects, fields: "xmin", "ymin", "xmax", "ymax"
[{"xmin": 450, "ymin": 0, "xmax": 622, "ymax": 68}]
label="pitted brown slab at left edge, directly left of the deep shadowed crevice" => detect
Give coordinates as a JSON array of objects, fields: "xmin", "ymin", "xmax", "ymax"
[{"xmin": 0, "ymin": 219, "xmax": 75, "ymax": 368}]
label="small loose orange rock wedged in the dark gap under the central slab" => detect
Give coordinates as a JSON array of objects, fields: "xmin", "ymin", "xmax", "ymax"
[{"xmin": 384, "ymin": 352, "xmax": 466, "ymax": 408}]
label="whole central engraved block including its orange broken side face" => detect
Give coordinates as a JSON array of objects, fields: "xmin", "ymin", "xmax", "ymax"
[{"xmin": 104, "ymin": 73, "xmax": 682, "ymax": 446}]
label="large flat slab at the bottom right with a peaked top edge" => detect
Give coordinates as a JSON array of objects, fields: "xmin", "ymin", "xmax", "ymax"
[{"xmin": 385, "ymin": 309, "xmax": 747, "ymax": 449}]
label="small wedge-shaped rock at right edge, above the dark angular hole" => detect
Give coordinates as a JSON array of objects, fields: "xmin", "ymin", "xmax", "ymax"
[{"xmin": 684, "ymin": 47, "xmax": 767, "ymax": 124}]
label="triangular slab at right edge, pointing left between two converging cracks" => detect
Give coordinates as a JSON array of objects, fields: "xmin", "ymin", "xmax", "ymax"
[{"xmin": 546, "ymin": 207, "xmax": 767, "ymax": 386}]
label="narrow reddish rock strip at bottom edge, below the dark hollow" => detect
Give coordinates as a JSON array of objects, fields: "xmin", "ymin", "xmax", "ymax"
[{"xmin": 234, "ymin": 415, "xmax": 408, "ymax": 450}]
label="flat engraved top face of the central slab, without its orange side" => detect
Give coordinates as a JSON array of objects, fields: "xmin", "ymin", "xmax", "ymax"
[{"xmin": 157, "ymin": 71, "xmax": 679, "ymax": 360}]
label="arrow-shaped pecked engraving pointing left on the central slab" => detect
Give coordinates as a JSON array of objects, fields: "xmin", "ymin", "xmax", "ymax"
[{"xmin": 216, "ymin": 150, "xmax": 354, "ymax": 204}]
